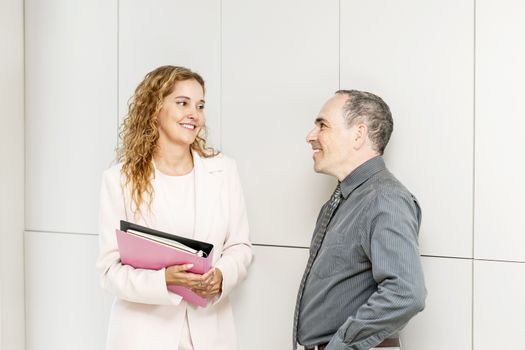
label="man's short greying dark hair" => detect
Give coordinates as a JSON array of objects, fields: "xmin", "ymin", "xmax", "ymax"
[{"xmin": 335, "ymin": 90, "xmax": 394, "ymax": 155}]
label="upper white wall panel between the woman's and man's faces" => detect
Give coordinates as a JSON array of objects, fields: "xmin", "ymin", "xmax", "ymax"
[{"xmin": 222, "ymin": 0, "xmax": 339, "ymax": 246}]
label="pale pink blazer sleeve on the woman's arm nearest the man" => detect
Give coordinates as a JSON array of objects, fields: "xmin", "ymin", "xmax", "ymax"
[{"xmin": 215, "ymin": 159, "xmax": 253, "ymax": 303}]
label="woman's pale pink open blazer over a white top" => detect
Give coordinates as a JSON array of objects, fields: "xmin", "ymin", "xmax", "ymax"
[{"xmin": 97, "ymin": 153, "xmax": 252, "ymax": 350}]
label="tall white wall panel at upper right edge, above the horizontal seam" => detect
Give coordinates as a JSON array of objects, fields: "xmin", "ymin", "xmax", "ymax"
[{"xmin": 474, "ymin": 0, "xmax": 525, "ymax": 261}]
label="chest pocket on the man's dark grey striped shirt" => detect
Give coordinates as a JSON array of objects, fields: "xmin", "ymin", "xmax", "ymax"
[{"xmin": 312, "ymin": 244, "xmax": 348, "ymax": 279}]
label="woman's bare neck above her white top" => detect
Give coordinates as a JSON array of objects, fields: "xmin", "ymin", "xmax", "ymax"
[{"xmin": 153, "ymin": 147, "xmax": 193, "ymax": 176}]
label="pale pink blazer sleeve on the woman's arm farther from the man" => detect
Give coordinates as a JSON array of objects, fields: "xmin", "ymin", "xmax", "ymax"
[{"xmin": 96, "ymin": 166, "xmax": 182, "ymax": 305}]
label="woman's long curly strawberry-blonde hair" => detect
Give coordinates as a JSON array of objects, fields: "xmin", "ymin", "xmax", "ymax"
[{"xmin": 117, "ymin": 66, "xmax": 217, "ymax": 215}]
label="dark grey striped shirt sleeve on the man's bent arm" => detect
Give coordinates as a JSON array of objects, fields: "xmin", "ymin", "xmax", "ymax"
[{"xmin": 326, "ymin": 193, "xmax": 426, "ymax": 350}]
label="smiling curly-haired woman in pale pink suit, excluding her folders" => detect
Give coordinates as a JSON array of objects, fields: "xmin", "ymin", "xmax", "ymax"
[{"xmin": 97, "ymin": 66, "xmax": 252, "ymax": 350}]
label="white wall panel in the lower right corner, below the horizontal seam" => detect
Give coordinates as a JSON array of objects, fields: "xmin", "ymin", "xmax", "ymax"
[{"xmin": 474, "ymin": 261, "xmax": 525, "ymax": 350}]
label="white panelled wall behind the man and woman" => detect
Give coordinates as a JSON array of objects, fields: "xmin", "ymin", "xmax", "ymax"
[{"xmin": 25, "ymin": 0, "xmax": 525, "ymax": 350}]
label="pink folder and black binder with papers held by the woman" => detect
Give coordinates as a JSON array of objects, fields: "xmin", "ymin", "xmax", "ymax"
[{"xmin": 115, "ymin": 220, "xmax": 213, "ymax": 307}]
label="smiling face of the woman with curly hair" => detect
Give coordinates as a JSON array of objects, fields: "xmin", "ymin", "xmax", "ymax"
[{"xmin": 158, "ymin": 79, "xmax": 204, "ymax": 147}]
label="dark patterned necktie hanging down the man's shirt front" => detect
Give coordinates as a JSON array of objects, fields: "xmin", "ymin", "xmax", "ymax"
[{"xmin": 293, "ymin": 185, "xmax": 341, "ymax": 350}]
